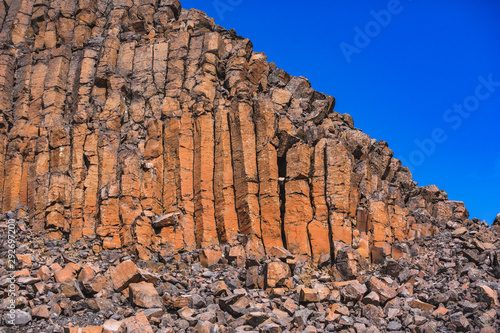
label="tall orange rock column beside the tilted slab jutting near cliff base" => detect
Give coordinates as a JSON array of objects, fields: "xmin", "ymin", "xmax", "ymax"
[{"xmin": 160, "ymin": 32, "xmax": 196, "ymax": 250}]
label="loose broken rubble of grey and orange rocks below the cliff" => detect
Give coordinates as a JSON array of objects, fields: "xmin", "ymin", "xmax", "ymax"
[{"xmin": 0, "ymin": 211, "xmax": 500, "ymax": 333}]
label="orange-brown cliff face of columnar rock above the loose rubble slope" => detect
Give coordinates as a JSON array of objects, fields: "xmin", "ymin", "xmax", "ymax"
[{"xmin": 0, "ymin": 0, "xmax": 468, "ymax": 262}]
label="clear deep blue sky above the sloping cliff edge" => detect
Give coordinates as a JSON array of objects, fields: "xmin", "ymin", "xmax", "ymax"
[{"xmin": 181, "ymin": 0, "xmax": 500, "ymax": 223}]
